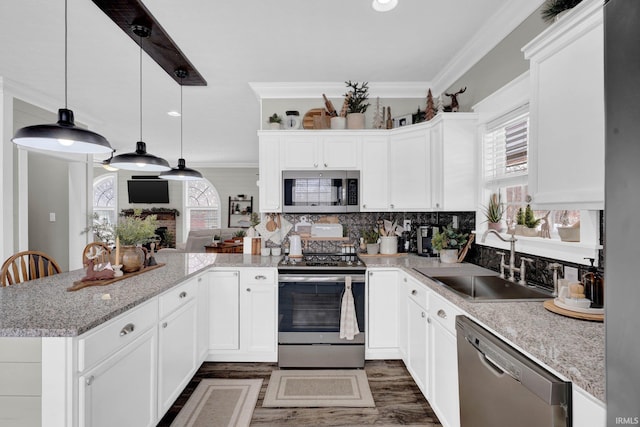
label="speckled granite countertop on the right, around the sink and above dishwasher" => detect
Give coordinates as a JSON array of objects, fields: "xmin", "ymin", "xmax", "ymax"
[{"xmin": 364, "ymin": 255, "xmax": 605, "ymax": 402}]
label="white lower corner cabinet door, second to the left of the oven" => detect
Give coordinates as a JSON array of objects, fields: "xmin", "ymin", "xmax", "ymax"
[{"xmin": 209, "ymin": 271, "xmax": 240, "ymax": 353}]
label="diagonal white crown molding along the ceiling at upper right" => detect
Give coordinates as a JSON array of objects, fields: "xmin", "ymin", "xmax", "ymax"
[{"xmin": 432, "ymin": 0, "xmax": 544, "ymax": 93}]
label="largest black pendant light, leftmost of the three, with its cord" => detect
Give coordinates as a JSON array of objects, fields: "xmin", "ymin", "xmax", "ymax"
[{"xmin": 11, "ymin": 0, "xmax": 113, "ymax": 154}]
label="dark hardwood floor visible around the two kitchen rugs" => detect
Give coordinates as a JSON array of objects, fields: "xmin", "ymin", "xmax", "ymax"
[{"xmin": 158, "ymin": 360, "xmax": 441, "ymax": 427}]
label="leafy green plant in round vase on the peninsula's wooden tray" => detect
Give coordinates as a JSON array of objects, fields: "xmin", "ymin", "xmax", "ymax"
[{"xmin": 114, "ymin": 215, "xmax": 158, "ymax": 273}]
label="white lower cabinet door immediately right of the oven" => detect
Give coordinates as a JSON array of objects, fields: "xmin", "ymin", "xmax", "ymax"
[{"xmin": 365, "ymin": 270, "xmax": 399, "ymax": 359}]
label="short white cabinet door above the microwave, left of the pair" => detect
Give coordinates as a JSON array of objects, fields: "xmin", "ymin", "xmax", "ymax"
[{"xmin": 280, "ymin": 131, "xmax": 323, "ymax": 170}]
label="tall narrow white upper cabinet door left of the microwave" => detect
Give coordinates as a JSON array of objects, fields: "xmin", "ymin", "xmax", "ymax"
[{"xmin": 258, "ymin": 135, "xmax": 282, "ymax": 212}]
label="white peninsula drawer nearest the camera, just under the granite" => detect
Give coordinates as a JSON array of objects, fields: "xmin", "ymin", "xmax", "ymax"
[{"xmin": 78, "ymin": 298, "xmax": 158, "ymax": 372}]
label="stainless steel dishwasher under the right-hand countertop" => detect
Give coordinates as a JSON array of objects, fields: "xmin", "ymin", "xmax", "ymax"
[{"xmin": 456, "ymin": 316, "xmax": 571, "ymax": 427}]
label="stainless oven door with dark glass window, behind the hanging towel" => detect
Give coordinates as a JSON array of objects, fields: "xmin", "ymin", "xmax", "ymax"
[{"xmin": 278, "ymin": 275, "xmax": 365, "ymax": 345}]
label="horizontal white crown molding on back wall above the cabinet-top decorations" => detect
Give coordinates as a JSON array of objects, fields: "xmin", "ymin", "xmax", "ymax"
[{"xmin": 249, "ymin": 82, "xmax": 431, "ymax": 101}]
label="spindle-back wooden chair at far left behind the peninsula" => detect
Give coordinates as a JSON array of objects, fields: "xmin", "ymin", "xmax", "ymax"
[{"xmin": 0, "ymin": 251, "xmax": 62, "ymax": 286}]
